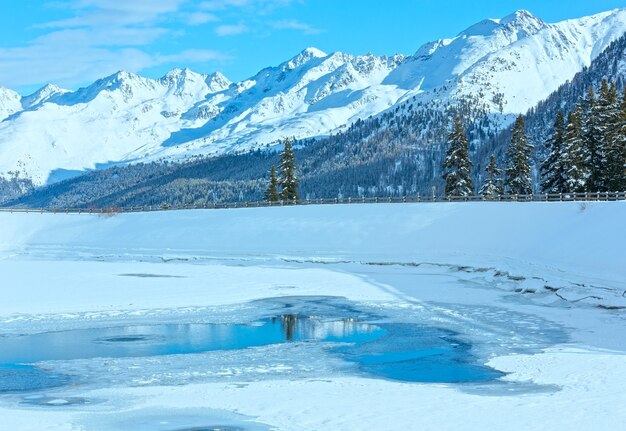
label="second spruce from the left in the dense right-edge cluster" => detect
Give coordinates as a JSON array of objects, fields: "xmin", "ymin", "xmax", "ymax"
[{"xmin": 563, "ymin": 105, "xmax": 589, "ymax": 193}]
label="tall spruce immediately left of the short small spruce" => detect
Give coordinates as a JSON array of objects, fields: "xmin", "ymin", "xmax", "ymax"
[{"xmin": 443, "ymin": 117, "xmax": 473, "ymax": 196}]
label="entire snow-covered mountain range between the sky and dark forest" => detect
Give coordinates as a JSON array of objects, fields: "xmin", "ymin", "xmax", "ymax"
[{"xmin": 0, "ymin": 9, "xmax": 626, "ymax": 184}]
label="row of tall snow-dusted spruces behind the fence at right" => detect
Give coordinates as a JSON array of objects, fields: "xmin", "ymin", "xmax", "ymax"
[{"xmin": 442, "ymin": 80, "xmax": 626, "ymax": 197}]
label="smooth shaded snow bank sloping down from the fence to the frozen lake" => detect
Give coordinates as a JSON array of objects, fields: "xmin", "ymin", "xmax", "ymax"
[{"xmin": 0, "ymin": 202, "xmax": 626, "ymax": 280}]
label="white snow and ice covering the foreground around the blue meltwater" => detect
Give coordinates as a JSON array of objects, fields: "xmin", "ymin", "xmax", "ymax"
[{"xmin": 0, "ymin": 202, "xmax": 626, "ymax": 430}]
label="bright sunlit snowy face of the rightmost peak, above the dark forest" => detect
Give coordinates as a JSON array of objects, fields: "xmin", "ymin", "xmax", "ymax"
[{"xmin": 454, "ymin": 10, "xmax": 626, "ymax": 113}]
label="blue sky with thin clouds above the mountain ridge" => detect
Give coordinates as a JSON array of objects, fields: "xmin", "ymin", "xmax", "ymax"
[{"xmin": 0, "ymin": 0, "xmax": 626, "ymax": 94}]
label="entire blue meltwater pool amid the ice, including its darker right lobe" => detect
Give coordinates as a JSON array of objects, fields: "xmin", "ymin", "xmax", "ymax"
[{"xmin": 0, "ymin": 315, "xmax": 501, "ymax": 392}]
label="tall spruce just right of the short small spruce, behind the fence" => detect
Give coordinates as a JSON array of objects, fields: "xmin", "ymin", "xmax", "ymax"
[{"xmin": 504, "ymin": 115, "xmax": 533, "ymax": 195}]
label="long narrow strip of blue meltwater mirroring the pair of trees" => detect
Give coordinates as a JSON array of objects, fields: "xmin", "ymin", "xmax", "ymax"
[{"xmin": 0, "ymin": 315, "xmax": 386, "ymax": 364}]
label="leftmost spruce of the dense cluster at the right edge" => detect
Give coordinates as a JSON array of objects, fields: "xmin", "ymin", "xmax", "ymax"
[{"xmin": 541, "ymin": 111, "xmax": 567, "ymax": 193}]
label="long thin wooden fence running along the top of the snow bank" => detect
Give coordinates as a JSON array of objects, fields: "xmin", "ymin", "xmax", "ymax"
[{"xmin": 0, "ymin": 192, "xmax": 626, "ymax": 215}]
